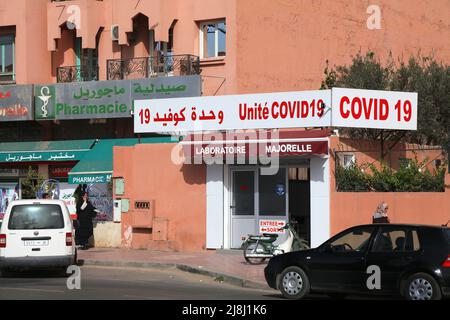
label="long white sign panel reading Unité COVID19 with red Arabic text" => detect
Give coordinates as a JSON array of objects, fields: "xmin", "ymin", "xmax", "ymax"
[{"xmin": 134, "ymin": 90, "xmax": 331, "ymax": 133}]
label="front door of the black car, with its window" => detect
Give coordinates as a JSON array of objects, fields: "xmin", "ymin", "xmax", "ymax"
[{"xmin": 307, "ymin": 226, "xmax": 375, "ymax": 291}]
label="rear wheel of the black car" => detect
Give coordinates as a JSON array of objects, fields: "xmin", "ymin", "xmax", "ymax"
[{"xmin": 403, "ymin": 273, "xmax": 442, "ymax": 300}]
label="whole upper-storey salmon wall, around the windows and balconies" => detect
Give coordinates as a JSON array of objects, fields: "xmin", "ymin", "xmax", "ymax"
[{"xmin": 4, "ymin": 0, "xmax": 450, "ymax": 91}]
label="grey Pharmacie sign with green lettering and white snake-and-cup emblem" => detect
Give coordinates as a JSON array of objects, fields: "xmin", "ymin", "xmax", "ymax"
[{"xmin": 34, "ymin": 76, "xmax": 201, "ymax": 120}]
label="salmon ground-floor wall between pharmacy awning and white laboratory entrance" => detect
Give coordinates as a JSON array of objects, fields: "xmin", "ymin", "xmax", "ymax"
[{"xmin": 113, "ymin": 143, "xmax": 206, "ymax": 252}]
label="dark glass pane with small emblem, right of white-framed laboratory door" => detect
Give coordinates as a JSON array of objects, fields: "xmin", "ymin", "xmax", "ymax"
[{"xmin": 259, "ymin": 168, "xmax": 286, "ymax": 216}]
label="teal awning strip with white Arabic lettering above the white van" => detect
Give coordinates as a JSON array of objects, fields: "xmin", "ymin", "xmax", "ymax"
[{"xmin": 0, "ymin": 151, "xmax": 86, "ymax": 162}]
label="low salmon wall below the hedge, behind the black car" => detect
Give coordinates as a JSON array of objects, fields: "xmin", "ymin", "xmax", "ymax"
[{"xmin": 330, "ymin": 137, "xmax": 450, "ymax": 236}]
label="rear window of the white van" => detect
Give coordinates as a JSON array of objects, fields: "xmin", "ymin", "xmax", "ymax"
[{"xmin": 8, "ymin": 204, "xmax": 64, "ymax": 230}]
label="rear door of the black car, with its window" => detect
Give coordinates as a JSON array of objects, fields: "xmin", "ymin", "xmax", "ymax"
[{"xmin": 367, "ymin": 226, "xmax": 420, "ymax": 293}]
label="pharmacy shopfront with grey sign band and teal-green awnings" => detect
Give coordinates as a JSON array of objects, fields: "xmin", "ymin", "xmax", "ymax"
[{"xmin": 0, "ymin": 76, "xmax": 201, "ymax": 232}]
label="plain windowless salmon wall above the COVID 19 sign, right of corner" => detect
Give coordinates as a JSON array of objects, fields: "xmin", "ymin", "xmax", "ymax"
[{"xmin": 234, "ymin": 0, "xmax": 450, "ymax": 93}]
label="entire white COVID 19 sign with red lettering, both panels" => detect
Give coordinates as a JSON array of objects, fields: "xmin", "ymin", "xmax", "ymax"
[{"xmin": 134, "ymin": 88, "xmax": 417, "ymax": 133}]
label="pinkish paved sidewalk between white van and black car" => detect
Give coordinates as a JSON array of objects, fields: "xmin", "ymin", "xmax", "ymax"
[{"xmin": 78, "ymin": 248, "xmax": 269, "ymax": 289}]
